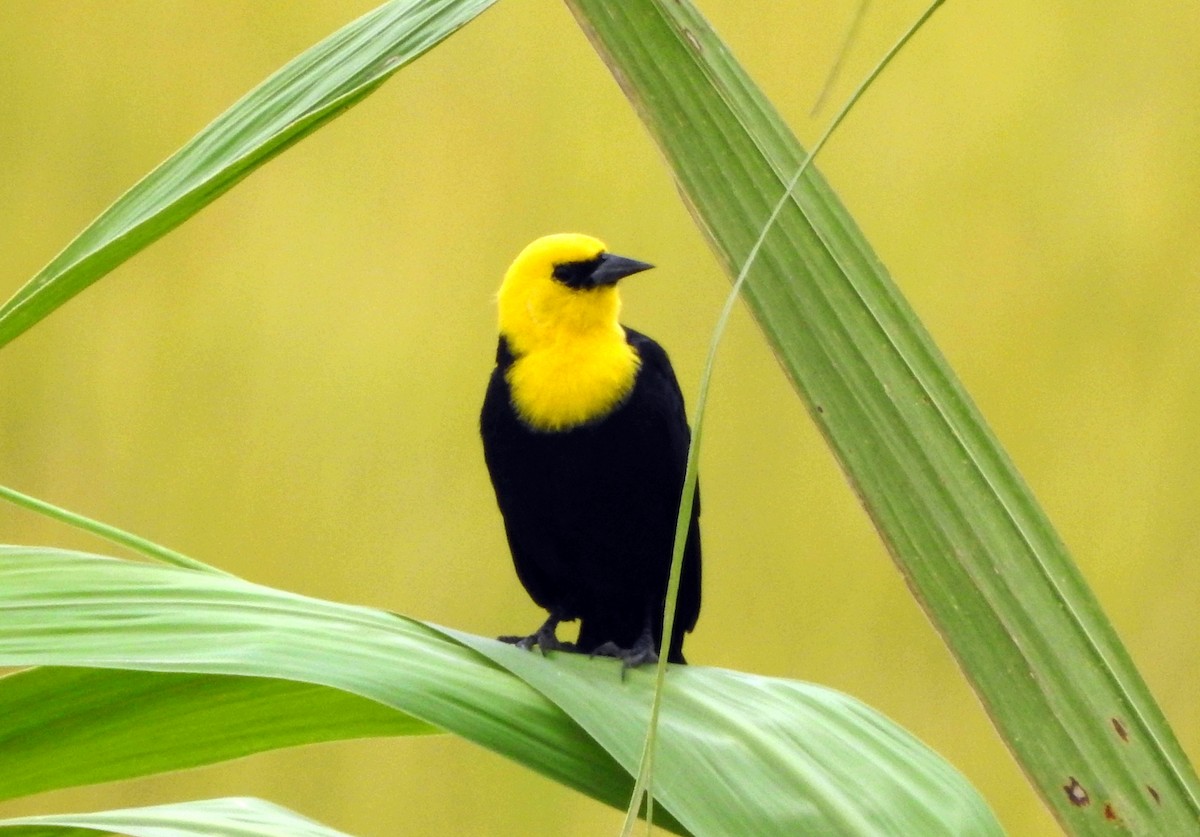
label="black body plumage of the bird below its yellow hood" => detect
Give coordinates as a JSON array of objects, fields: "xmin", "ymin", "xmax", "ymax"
[{"xmin": 480, "ymin": 329, "xmax": 701, "ymax": 664}]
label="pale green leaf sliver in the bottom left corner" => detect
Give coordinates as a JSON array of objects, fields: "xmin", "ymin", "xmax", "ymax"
[{"xmin": 0, "ymin": 797, "xmax": 346, "ymax": 837}]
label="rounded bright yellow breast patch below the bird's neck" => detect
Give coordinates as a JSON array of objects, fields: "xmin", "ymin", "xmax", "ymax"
[{"xmin": 506, "ymin": 326, "xmax": 640, "ymax": 430}]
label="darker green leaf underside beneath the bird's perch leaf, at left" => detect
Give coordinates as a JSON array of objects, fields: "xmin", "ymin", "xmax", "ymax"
[{"xmin": 0, "ymin": 668, "xmax": 432, "ymax": 799}]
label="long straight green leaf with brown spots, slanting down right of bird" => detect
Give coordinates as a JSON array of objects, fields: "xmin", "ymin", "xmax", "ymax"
[{"xmin": 568, "ymin": 0, "xmax": 1200, "ymax": 835}]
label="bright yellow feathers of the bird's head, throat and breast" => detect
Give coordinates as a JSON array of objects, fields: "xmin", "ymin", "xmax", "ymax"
[{"xmin": 497, "ymin": 234, "xmax": 640, "ymax": 432}]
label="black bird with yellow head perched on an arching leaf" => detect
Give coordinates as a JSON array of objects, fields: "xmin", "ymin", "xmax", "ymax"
[{"xmin": 480, "ymin": 233, "xmax": 701, "ymax": 674}]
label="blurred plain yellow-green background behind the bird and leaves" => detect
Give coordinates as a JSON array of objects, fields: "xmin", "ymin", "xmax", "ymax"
[{"xmin": 0, "ymin": 0, "xmax": 1200, "ymax": 835}]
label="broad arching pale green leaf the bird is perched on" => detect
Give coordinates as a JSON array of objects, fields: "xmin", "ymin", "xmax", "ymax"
[{"xmin": 0, "ymin": 547, "xmax": 1000, "ymax": 835}]
